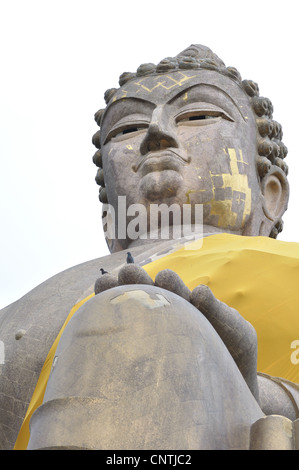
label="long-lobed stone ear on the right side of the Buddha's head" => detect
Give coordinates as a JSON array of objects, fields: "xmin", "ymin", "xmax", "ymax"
[{"xmin": 260, "ymin": 165, "xmax": 289, "ymax": 236}]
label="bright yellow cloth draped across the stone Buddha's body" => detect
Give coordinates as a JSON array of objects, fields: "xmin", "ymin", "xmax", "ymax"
[{"xmin": 15, "ymin": 233, "xmax": 299, "ymax": 450}]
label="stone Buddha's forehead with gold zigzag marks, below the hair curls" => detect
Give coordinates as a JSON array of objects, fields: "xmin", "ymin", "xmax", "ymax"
[{"xmin": 112, "ymin": 70, "xmax": 248, "ymax": 106}]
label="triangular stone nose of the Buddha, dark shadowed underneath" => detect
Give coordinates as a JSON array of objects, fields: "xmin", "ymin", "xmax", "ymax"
[{"xmin": 140, "ymin": 106, "xmax": 179, "ymax": 155}]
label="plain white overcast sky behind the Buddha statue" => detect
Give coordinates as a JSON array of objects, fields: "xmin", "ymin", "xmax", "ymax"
[{"xmin": 0, "ymin": 0, "xmax": 299, "ymax": 308}]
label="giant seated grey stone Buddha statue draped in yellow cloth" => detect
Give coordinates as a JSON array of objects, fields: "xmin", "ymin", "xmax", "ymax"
[{"xmin": 0, "ymin": 45, "xmax": 299, "ymax": 450}]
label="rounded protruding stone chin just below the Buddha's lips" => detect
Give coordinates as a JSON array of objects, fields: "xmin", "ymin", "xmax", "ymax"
[{"xmin": 139, "ymin": 170, "xmax": 184, "ymax": 202}]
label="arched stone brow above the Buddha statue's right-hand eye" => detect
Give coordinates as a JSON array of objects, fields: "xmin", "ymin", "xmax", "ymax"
[{"xmin": 167, "ymin": 83, "xmax": 247, "ymax": 122}]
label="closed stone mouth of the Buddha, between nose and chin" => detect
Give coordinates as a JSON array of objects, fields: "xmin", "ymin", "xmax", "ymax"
[{"xmin": 132, "ymin": 149, "xmax": 190, "ymax": 176}]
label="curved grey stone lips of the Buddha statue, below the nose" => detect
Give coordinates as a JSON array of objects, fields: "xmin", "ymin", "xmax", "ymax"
[{"xmin": 132, "ymin": 149, "xmax": 189, "ymax": 172}]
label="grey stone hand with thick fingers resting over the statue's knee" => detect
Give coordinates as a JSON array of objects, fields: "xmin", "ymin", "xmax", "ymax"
[{"xmin": 95, "ymin": 264, "xmax": 258, "ymax": 399}]
